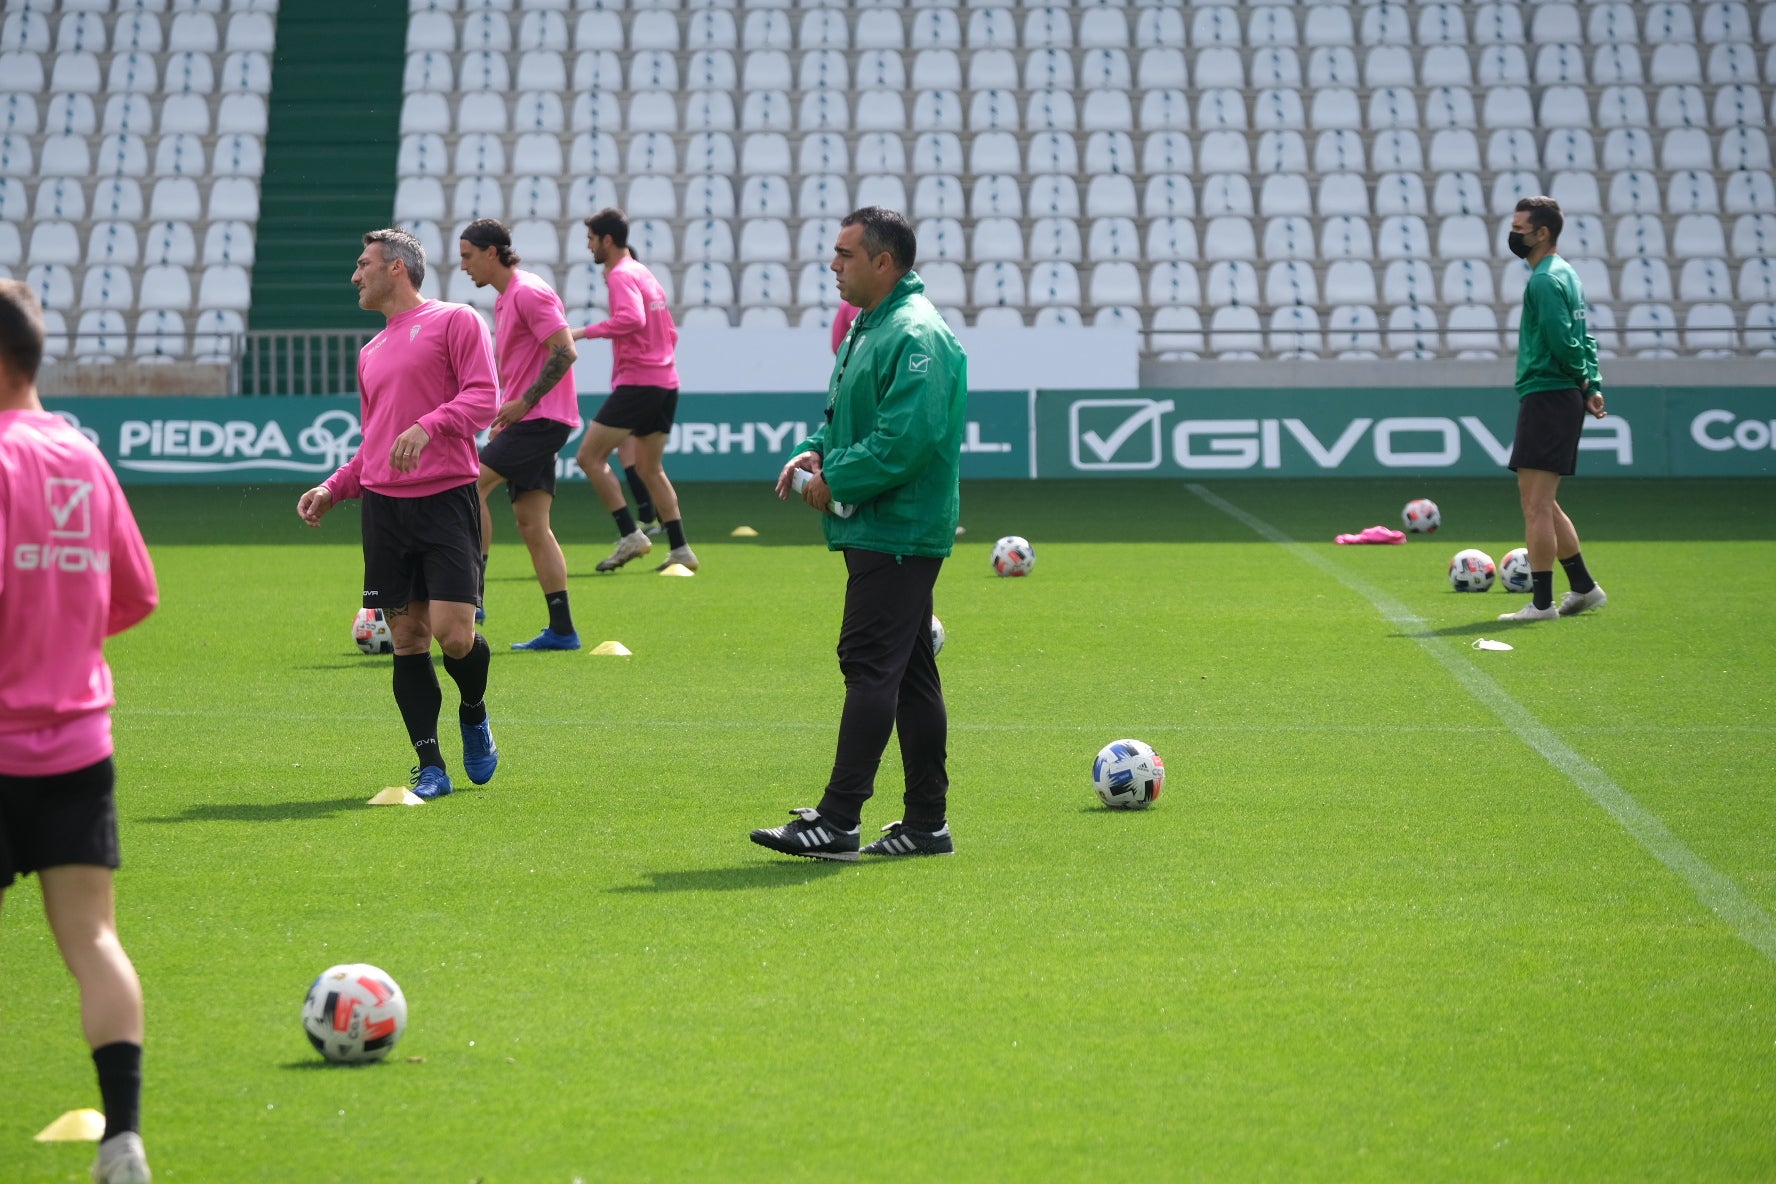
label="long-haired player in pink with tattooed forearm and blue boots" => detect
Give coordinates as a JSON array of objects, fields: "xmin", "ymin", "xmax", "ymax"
[{"xmin": 456, "ymin": 218, "xmax": 579, "ymax": 650}]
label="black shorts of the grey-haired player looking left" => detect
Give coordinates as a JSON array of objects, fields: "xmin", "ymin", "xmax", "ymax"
[{"xmin": 362, "ymin": 481, "xmax": 481, "ymax": 611}]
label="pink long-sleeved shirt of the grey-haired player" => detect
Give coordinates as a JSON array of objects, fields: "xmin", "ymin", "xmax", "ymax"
[{"xmin": 325, "ymin": 300, "xmax": 499, "ymax": 502}]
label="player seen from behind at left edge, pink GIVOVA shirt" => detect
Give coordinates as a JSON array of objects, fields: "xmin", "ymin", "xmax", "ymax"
[{"xmin": 0, "ymin": 280, "xmax": 160, "ymax": 1184}]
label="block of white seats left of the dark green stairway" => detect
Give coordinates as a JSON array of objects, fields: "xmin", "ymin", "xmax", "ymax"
[{"xmin": 0, "ymin": 0, "xmax": 277, "ymax": 362}]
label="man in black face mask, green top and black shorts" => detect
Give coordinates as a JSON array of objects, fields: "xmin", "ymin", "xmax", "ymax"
[{"xmin": 1499, "ymin": 197, "xmax": 1607, "ymax": 621}]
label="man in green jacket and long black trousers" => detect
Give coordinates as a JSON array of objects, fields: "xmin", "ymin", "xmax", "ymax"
[{"xmin": 753, "ymin": 206, "xmax": 968, "ymax": 859}]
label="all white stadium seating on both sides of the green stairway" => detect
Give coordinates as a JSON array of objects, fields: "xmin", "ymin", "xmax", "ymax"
[{"xmin": 0, "ymin": 0, "xmax": 1776, "ymax": 359}]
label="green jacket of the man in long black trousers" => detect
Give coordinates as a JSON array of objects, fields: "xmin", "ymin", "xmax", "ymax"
[{"xmin": 796, "ymin": 272, "xmax": 968, "ymax": 559}]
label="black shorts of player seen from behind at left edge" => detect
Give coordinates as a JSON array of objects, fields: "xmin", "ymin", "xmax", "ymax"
[{"xmin": 0, "ymin": 756, "xmax": 123, "ymax": 889}]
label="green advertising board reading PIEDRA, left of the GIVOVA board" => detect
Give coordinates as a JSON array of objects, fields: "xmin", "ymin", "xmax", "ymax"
[{"xmin": 46, "ymin": 391, "xmax": 1030, "ymax": 485}]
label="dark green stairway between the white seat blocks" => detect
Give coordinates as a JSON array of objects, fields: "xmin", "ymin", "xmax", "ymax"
[{"xmin": 247, "ymin": 0, "xmax": 407, "ymax": 328}]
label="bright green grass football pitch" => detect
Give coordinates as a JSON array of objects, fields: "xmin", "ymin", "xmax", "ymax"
[{"xmin": 0, "ymin": 479, "xmax": 1776, "ymax": 1184}]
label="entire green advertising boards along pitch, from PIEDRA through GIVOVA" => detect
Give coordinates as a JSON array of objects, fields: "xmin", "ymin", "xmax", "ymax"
[{"xmin": 48, "ymin": 387, "xmax": 1776, "ymax": 485}]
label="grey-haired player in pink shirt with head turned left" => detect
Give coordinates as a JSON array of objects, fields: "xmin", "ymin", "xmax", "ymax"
[{"xmin": 297, "ymin": 229, "xmax": 499, "ymax": 801}]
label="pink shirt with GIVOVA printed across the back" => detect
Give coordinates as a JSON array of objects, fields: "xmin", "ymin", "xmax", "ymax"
[{"xmin": 0, "ymin": 410, "xmax": 160, "ymax": 777}]
